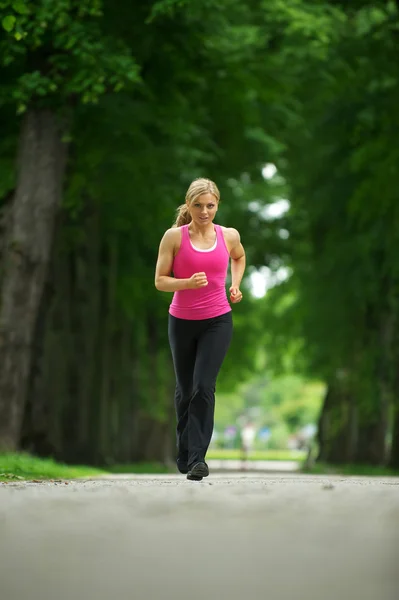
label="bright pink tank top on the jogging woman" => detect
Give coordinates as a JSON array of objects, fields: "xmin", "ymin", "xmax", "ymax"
[{"xmin": 169, "ymin": 225, "xmax": 231, "ymax": 321}]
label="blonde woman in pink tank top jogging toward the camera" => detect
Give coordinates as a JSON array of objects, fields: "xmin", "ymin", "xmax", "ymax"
[{"xmin": 155, "ymin": 179, "xmax": 245, "ymax": 481}]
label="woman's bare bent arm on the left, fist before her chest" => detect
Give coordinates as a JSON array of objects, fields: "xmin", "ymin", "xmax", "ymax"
[{"xmin": 155, "ymin": 228, "xmax": 208, "ymax": 292}]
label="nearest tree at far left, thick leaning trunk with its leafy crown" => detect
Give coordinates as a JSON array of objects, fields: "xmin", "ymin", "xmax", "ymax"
[{"xmin": 0, "ymin": 0, "xmax": 138, "ymax": 449}]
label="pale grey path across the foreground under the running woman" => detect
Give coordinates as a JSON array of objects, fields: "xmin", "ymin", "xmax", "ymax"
[{"xmin": 0, "ymin": 473, "xmax": 399, "ymax": 600}]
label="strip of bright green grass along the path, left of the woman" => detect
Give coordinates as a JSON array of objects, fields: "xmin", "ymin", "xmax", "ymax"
[{"xmin": 0, "ymin": 453, "xmax": 174, "ymax": 481}]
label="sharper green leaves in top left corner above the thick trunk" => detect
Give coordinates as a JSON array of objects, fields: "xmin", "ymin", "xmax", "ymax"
[{"xmin": 0, "ymin": 0, "xmax": 140, "ymax": 113}]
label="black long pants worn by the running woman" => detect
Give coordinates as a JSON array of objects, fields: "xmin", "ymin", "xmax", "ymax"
[{"xmin": 168, "ymin": 311, "xmax": 233, "ymax": 466}]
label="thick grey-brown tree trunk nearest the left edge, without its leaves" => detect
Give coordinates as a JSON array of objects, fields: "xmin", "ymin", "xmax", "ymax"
[{"xmin": 0, "ymin": 110, "xmax": 67, "ymax": 450}]
